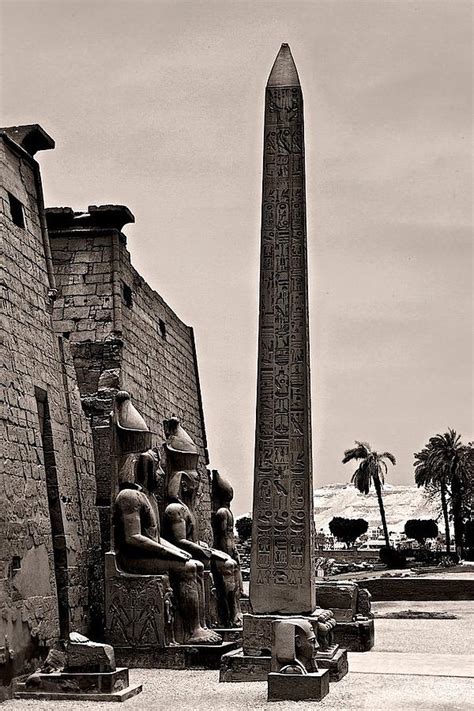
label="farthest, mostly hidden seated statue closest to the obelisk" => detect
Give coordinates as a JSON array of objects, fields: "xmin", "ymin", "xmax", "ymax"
[{"xmin": 211, "ymin": 469, "xmax": 243, "ymax": 627}]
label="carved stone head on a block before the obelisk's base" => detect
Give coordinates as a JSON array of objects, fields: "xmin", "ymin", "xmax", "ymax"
[{"xmin": 272, "ymin": 617, "xmax": 318, "ymax": 674}]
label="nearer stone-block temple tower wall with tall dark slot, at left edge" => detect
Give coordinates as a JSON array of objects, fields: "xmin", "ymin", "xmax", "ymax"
[{"xmin": 0, "ymin": 126, "xmax": 100, "ymax": 699}]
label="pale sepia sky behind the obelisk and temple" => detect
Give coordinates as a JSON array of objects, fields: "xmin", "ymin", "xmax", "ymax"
[{"xmin": 1, "ymin": 0, "xmax": 473, "ymax": 514}]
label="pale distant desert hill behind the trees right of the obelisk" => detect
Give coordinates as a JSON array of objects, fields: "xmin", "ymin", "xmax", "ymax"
[{"xmin": 314, "ymin": 484, "xmax": 443, "ymax": 532}]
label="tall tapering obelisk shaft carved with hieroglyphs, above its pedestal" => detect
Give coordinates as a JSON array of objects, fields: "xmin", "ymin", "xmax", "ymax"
[{"xmin": 250, "ymin": 44, "xmax": 316, "ymax": 615}]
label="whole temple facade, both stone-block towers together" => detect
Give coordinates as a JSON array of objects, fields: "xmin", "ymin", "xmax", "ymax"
[{"xmin": 0, "ymin": 125, "xmax": 211, "ymax": 701}]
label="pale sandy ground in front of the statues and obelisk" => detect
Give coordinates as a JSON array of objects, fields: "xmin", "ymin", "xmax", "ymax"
[{"xmin": 2, "ymin": 602, "xmax": 474, "ymax": 711}]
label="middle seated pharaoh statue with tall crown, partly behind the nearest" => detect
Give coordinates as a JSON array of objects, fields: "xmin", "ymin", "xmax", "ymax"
[{"xmin": 163, "ymin": 417, "xmax": 241, "ymax": 626}]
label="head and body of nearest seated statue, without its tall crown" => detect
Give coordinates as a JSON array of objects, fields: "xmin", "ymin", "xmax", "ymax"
[{"xmin": 113, "ymin": 428, "xmax": 221, "ymax": 644}]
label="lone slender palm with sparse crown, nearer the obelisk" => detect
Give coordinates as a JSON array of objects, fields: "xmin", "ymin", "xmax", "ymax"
[{"xmin": 342, "ymin": 442, "xmax": 397, "ymax": 548}]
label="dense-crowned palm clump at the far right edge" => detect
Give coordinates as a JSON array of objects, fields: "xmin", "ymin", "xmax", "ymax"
[{"xmin": 414, "ymin": 429, "xmax": 472, "ymax": 554}]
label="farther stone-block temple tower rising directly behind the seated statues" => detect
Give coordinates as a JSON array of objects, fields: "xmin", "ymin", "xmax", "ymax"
[{"xmin": 46, "ymin": 200, "xmax": 211, "ymax": 630}]
